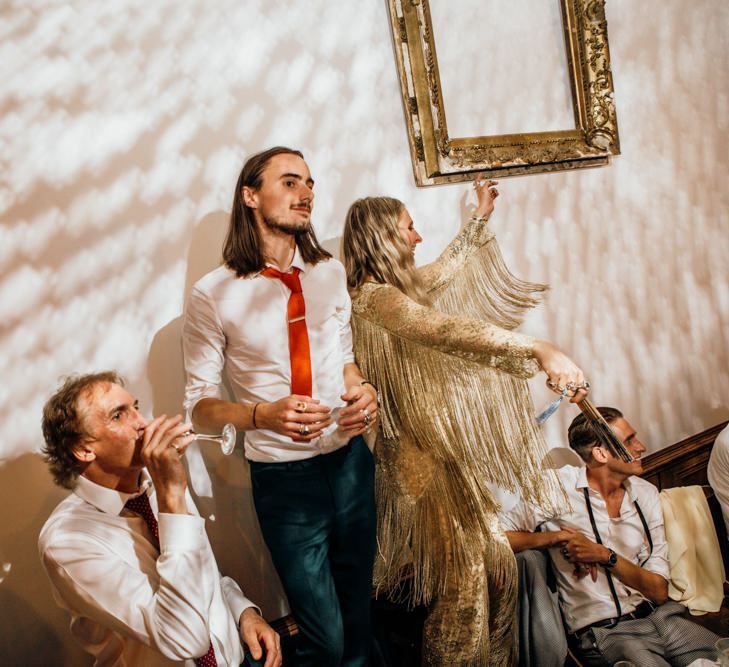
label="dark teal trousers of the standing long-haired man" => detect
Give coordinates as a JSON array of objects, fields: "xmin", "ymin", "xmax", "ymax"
[{"xmin": 251, "ymin": 436, "xmax": 376, "ymax": 667}]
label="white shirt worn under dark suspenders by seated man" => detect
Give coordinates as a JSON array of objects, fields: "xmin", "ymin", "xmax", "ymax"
[{"xmin": 499, "ymin": 466, "xmax": 669, "ymax": 632}]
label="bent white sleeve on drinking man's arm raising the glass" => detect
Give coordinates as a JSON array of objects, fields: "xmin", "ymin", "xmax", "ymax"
[{"xmin": 42, "ymin": 514, "xmax": 217, "ymax": 660}]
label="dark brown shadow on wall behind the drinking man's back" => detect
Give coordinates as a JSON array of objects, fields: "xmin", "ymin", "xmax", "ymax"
[{"xmin": 0, "ymin": 454, "xmax": 92, "ymax": 667}]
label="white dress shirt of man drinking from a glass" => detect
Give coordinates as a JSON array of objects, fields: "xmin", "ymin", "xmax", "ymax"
[{"xmin": 38, "ymin": 471, "xmax": 253, "ymax": 667}]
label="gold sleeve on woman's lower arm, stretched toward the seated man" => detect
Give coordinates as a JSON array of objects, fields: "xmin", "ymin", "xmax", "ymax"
[{"xmin": 354, "ymin": 283, "xmax": 539, "ymax": 378}]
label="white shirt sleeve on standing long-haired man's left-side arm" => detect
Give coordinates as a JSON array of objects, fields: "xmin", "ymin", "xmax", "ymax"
[{"xmin": 182, "ymin": 287, "xmax": 225, "ymax": 418}]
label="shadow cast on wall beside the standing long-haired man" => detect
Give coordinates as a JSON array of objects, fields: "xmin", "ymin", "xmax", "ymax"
[{"xmin": 147, "ymin": 211, "xmax": 288, "ymax": 620}]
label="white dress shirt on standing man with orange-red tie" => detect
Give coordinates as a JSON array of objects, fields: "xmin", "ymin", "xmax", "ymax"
[{"xmin": 182, "ymin": 249, "xmax": 354, "ymax": 462}]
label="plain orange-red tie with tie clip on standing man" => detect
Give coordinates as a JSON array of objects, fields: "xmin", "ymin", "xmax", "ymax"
[{"xmin": 261, "ymin": 266, "xmax": 312, "ymax": 396}]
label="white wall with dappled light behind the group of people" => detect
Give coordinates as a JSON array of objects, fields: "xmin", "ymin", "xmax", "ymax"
[{"xmin": 0, "ymin": 0, "xmax": 729, "ymax": 665}]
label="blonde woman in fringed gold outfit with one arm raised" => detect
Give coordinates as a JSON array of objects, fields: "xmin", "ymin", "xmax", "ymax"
[{"xmin": 343, "ymin": 178, "xmax": 587, "ymax": 666}]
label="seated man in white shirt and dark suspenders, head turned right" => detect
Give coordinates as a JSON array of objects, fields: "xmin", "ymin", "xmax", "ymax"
[{"xmin": 501, "ymin": 408, "xmax": 718, "ymax": 667}]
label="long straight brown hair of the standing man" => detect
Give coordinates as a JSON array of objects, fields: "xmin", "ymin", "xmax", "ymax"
[{"xmin": 223, "ymin": 146, "xmax": 331, "ymax": 278}]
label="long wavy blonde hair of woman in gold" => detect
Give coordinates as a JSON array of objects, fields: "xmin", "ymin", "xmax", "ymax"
[{"xmin": 342, "ymin": 197, "xmax": 428, "ymax": 303}]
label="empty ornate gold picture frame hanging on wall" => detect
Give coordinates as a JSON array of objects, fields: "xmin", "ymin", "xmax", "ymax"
[{"xmin": 388, "ymin": 0, "xmax": 620, "ymax": 186}]
